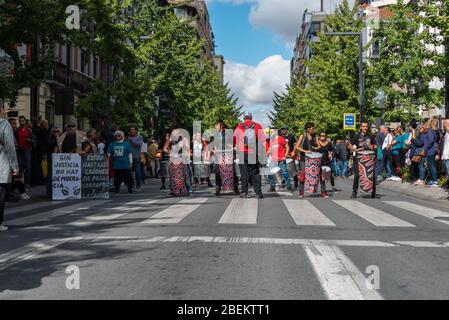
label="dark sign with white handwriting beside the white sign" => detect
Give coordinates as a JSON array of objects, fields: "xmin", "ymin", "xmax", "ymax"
[{"xmin": 81, "ymin": 154, "xmax": 109, "ymax": 199}]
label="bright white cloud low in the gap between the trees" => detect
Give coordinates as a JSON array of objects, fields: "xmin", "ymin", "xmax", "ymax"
[{"xmin": 224, "ymin": 55, "xmax": 290, "ymax": 125}]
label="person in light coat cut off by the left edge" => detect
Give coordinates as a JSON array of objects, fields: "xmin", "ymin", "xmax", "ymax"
[{"xmin": 0, "ymin": 101, "xmax": 19, "ymax": 231}]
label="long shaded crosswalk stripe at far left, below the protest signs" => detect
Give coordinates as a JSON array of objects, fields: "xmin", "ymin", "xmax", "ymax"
[{"xmin": 7, "ymin": 200, "xmax": 110, "ymax": 225}]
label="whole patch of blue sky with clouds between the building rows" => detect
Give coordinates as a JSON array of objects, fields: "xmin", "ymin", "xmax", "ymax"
[{"xmin": 205, "ymin": 0, "xmax": 353, "ymax": 126}]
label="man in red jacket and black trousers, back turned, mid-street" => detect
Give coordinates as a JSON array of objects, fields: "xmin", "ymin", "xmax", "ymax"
[{"xmin": 234, "ymin": 112, "xmax": 266, "ymax": 199}]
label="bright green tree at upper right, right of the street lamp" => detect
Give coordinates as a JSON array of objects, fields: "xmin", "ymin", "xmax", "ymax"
[{"xmin": 367, "ymin": 0, "xmax": 442, "ymax": 123}]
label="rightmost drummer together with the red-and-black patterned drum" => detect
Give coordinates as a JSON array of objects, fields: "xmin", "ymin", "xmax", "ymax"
[{"xmin": 349, "ymin": 122, "xmax": 377, "ymax": 198}]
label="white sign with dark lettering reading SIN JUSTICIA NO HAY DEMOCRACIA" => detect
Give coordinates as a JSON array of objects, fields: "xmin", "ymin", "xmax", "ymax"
[{"xmin": 52, "ymin": 153, "xmax": 81, "ymax": 200}]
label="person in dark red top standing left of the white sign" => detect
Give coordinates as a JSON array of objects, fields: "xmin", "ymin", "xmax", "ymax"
[{"xmin": 17, "ymin": 116, "xmax": 32, "ymax": 184}]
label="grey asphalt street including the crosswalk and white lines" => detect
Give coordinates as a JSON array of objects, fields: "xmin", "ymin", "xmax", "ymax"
[{"xmin": 0, "ymin": 179, "xmax": 449, "ymax": 300}]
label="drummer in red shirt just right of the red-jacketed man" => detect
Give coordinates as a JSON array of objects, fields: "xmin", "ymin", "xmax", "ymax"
[{"xmin": 268, "ymin": 127, "xmax": 293, "ymax": 192}]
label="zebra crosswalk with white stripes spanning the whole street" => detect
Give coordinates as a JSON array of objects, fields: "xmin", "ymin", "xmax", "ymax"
[{"xmin": 6, "ymin": 196, "xmax": 449, "ymax": 230}]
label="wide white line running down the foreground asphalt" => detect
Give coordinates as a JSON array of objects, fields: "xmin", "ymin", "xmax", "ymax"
[{"xmin": 304, "ymin": 245, "xmax": 382, "ymax": 300}]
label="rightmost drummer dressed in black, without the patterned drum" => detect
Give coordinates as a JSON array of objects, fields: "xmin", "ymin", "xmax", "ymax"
[{"xmin": 350, "ymin": 122, "xmax": 377, "ymax": 199}]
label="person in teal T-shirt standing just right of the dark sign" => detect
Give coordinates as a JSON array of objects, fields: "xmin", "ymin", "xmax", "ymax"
[{"xmin": 108, "ymin": 130, "xmax": 133, "ymax": 193}]
